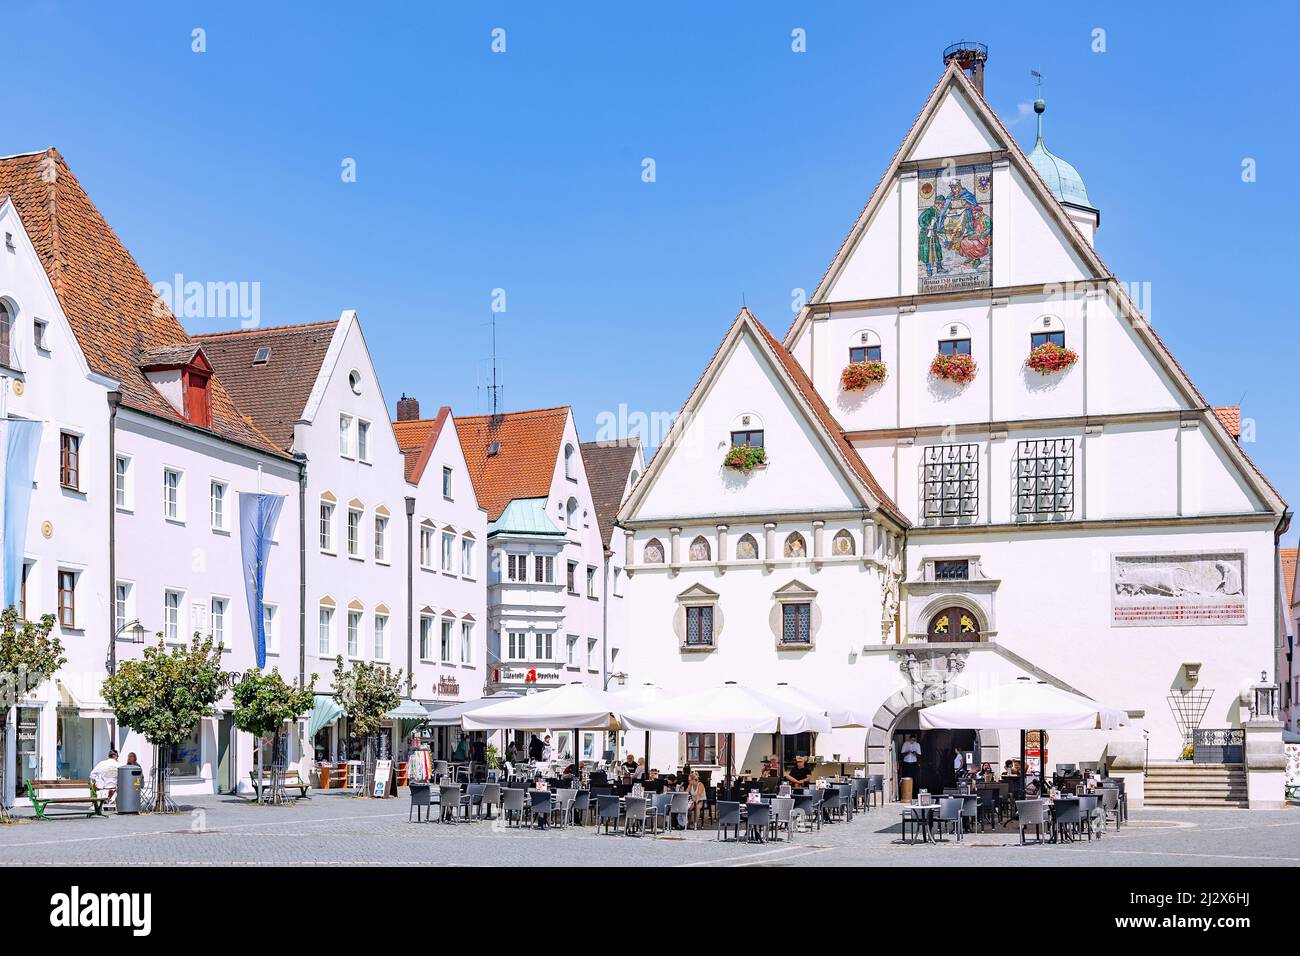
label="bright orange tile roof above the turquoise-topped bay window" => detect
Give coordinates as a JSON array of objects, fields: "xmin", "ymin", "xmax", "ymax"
[{"xmin": 456, "ymin": 405, "xmax": 569, "ymax": 522}]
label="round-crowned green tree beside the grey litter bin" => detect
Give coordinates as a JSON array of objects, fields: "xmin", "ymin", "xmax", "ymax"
[{"xmin": 104, "ymin": 633, "xmax": 231, "ymax": 813}]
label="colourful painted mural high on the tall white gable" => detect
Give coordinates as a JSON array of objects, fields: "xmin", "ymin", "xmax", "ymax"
[{"xmin": 917, "ymin": 163, "xmax": 993, "ymax": 293}]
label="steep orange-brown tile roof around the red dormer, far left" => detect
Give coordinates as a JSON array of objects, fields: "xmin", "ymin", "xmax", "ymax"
[{"xmin": 0, "ymin": 148, "xmax": 280, "ymax": 453}]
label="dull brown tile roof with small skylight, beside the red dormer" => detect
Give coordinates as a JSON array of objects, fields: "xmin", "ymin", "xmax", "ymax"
[{"xmin": 194, "ymin": 320, "xmax": 338, "ymax": 450}]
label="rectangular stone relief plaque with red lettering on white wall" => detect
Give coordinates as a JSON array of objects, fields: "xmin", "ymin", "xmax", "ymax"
[{"xmin": 1110, "ymin": 551, "xmax": 1247, "ymax": 627}]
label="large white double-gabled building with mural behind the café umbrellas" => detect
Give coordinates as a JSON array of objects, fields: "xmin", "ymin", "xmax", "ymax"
[{"xmin": 619, "ymin": 48, "xmax": 1288, "ymax": 805}]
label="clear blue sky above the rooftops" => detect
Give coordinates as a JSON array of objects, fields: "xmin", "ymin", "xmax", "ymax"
[{"xmin": 0, "ymin": 0, "xmax": 1300, "ymax": 528}]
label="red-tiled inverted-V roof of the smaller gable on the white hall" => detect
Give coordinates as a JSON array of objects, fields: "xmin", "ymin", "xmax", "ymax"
[{"xmin": 620, "ymin": 307, "xmax": 911, "ymax": 528}]
